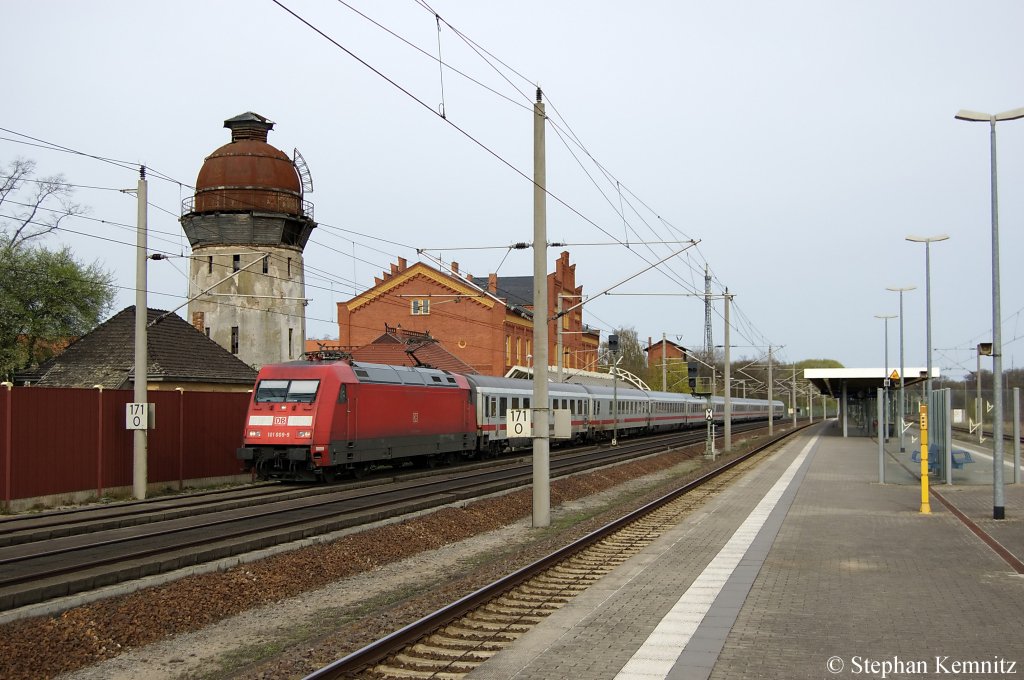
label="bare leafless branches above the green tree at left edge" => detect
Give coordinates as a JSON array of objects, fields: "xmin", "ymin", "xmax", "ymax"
[{"xmin": 0, "ymin": 158, "xmax": 87, "ymax": 250}]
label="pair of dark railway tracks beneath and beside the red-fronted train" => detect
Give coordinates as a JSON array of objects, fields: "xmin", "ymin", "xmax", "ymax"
[{"xmin": 0, "ymin": 432, "xmax": 770, "ymax": 620}]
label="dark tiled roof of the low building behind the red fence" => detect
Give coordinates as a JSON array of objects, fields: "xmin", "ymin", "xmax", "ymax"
[{"xmin": 15, "ymin": 306, "xmax": 256, "ymax": 391}]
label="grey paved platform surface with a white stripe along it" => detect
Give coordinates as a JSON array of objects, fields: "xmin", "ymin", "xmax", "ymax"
[{"xmin": 468, "ymin": 423, "xmax": 1024, "ymax": 680}]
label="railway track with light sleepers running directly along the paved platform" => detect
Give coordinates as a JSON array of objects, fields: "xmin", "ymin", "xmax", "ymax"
[{"xmin": 307, "ymin": 421, "xmax": 803, "ymax": 680}]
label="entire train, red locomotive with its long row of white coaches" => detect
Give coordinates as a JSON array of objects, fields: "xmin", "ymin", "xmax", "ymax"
[{"xmin": 237, "ymin": 355, "xmax": 784, "ymax": 481}]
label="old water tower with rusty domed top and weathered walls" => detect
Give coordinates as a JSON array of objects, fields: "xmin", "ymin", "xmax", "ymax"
[{"xmin": 181, "ymin": 112, "xmax": 316, "ymax": 368}]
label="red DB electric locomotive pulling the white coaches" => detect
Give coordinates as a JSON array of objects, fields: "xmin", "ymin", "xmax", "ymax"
[{"xmin": 238, "ymin": 360, "xmax": 476, "ymax": 480}]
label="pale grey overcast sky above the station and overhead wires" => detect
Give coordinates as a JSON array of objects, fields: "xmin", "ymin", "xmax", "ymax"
[{"xmin": 0, "ymin": 0, "xmax": 1024, "ymax": 375}]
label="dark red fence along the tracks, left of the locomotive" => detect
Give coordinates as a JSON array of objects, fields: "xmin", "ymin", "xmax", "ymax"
[{"xmin": 0, "ymin": 387, "xmax": 249, "ymax": 508}]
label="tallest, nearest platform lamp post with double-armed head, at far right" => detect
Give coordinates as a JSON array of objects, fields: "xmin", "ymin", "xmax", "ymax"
[{"xmin": 955, "ymin": 109, "xmax": 1024, "ymax": 519}]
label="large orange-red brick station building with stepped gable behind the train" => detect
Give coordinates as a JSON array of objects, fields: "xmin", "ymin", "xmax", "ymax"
[{"xmin": 338, "ymin": 252, "xmax": 600, "ymax": 376}]
